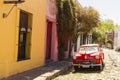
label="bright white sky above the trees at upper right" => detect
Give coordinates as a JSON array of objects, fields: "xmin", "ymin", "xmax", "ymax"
[{"xmin": 78, "ymin": 0, "xmax": 120, "ymax": 24}]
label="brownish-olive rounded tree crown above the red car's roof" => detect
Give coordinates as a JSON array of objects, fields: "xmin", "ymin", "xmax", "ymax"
[{"xmin": 78, "ymin": 7, "xmax": 100, "ymax": 44}]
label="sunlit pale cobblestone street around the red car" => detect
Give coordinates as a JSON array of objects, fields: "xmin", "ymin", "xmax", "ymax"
[{"xmin": 53, "ymin": 49, "xmax": 120, "ymax": 80}]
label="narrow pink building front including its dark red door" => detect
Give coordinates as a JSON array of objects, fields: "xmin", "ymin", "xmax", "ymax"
[{"xmin": 45, "ymin": 0, "xmax": 58, "ymax": 61}]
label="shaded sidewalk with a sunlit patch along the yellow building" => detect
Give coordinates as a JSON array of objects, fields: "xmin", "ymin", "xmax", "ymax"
[{"xmin": 0, "ymin": 61, "xmax": 71, "ymax": 80}]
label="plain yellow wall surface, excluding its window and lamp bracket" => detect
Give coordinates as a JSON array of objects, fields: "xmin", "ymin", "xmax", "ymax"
[{"xmin": 0, "ymin": 0, "xmax": 46, "ymax": 78}]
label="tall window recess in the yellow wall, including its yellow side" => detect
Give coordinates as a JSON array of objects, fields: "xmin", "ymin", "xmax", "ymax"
[{"xmin": 17, "ymin": 10, "xmax": 32, "ymax": 61}]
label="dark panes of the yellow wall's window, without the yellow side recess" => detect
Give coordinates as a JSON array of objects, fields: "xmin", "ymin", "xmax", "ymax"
[{"xmin": 18, "ymin": 11, "xmax": 28, "ymax": 61}]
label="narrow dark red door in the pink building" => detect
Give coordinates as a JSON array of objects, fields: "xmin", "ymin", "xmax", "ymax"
[{"xmin": 46, "ymin": 21, "xmax": 52, "ymax": 59}]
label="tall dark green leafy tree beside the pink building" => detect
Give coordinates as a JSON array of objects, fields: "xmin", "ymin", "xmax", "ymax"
[{"xmin": 56, "ymin": 0, "xmax": 77, "ymax": 60}]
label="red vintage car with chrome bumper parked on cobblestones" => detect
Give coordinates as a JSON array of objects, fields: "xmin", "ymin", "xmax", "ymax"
[{"xmin": 72, "ymin": 44, "xmax": 104, "ymax": 70}]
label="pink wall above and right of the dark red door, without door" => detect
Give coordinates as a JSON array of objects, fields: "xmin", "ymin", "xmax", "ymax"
[{"xmin": 45, "ymin": 0, "xmax": 58, "ymax": 61}]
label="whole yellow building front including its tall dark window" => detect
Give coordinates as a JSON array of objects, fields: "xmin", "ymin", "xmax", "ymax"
[{"xmin": 0, "ymin": 0, "xmax": 46, "ymax": 78}]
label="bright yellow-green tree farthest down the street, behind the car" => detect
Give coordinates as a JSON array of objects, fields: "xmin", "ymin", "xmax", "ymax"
[{"xmin": 93, "ymin": 19, "xmax": 117, "ymax": 44}]
